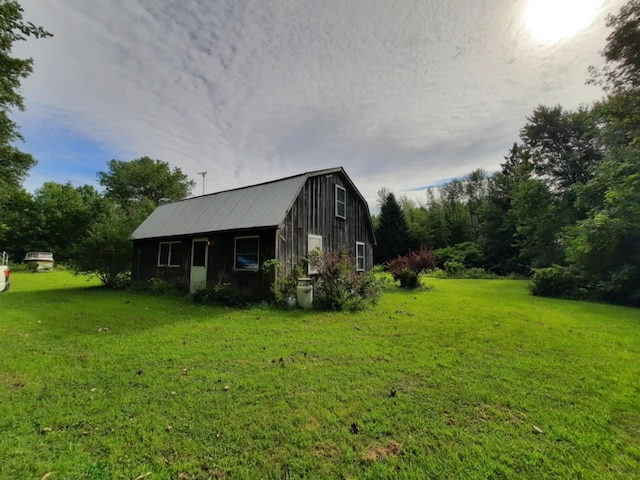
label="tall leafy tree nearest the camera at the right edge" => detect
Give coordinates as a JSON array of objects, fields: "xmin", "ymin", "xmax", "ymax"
[{"xmin": 565, "ymin": 0, "xmax": 640, "ymax": 305}]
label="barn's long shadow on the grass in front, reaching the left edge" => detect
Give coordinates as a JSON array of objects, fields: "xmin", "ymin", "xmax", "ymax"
[{"xmin": 3, "ymin": 284, "xmax": 315, "ymax": 340}]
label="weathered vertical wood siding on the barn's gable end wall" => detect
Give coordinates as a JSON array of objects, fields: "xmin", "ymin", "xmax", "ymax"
[{"xmin": 277, "ymin": 173, "xmax": 374, "ymax": 276}]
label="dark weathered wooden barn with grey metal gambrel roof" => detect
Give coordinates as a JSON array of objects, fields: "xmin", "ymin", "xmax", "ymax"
[{"xmin": 131, "ymin": 167, "xmax": 375, "ymax": 299}]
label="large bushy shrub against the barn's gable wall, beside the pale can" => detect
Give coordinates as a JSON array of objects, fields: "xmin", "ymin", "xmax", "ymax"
[{"xmin": 312, "ymin": 252, "xmax": 382, "ymax": 311}]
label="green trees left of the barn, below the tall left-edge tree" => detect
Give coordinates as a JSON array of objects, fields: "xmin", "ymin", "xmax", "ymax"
[{"xmin": 0, "ymin": 157, "xmax": 195, "ymax": 285}]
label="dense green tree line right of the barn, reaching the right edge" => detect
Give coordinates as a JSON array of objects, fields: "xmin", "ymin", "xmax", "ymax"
[{"xmin": 375, "ymin": 0, "xmax": 640, "ymax": 305}]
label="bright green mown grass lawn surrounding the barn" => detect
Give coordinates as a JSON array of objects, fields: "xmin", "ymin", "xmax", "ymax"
[{"xmin": 0, "ymin": 271, "xmax": 640, "ymax": 480}]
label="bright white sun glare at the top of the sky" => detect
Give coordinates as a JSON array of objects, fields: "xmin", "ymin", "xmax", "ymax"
[{"xmin": 524, "ymin": 0, "xmax": 602, "ymax": 42}]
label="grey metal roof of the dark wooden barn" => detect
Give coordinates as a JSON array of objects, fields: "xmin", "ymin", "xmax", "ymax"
[{"xmin": 131, "ymin": 167, "xmax": 350, "ymax": 240}]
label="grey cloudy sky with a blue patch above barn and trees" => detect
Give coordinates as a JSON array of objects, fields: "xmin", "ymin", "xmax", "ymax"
[{"xmin": 14, "ymin": 0, "xmax": 624, "ymax": 210}]
